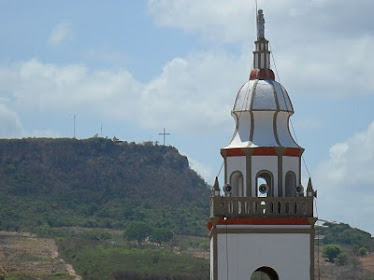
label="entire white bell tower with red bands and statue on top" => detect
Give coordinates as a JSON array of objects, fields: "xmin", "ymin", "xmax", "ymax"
[{"xmin": 208, "ymin": 10, "xmax": 316, "ymax": 280}]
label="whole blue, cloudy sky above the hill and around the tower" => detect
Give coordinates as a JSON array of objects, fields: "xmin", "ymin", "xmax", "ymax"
[{"xmin": 0, "ymin": 0, "xmax": 374, "ymax": 234}]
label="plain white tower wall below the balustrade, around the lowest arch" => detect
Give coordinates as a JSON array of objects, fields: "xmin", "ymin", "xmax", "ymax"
[{"xmin": 217, "ymin": 233, "xmax": 311, "ymax": 280}]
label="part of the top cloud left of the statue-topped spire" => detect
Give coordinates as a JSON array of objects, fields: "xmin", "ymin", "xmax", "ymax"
[{"xmin": 148, "ymin": 0, "xmax": 255, "ymax": 42}]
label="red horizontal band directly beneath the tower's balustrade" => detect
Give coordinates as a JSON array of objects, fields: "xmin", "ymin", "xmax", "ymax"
[{"xmin": 207, "ymin": 217, "xmax": 311, "ymax": 230}]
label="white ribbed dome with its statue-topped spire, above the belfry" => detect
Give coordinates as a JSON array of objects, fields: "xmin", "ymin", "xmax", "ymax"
[{"xmin": 224, "ymin": 10, "xmax": 302, "ymax": 151}]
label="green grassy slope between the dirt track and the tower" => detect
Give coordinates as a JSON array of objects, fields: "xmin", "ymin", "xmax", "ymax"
[{"xmin": 57, "ymin": 229, "xmax": 209, "ymax": 280}]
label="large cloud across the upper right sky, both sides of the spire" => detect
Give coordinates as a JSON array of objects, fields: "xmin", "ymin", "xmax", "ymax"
[{"xmin": 148, "ymin": 0, "xmax": 374, "ymax": 98}]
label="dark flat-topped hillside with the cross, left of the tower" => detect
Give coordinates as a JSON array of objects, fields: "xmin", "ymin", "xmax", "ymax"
[{"xmin": 0, "ymin": 138, "xmax": 209, "ymax": 235}]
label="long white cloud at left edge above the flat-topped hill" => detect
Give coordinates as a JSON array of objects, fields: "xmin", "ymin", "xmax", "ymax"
[{"xmin": 0, "ymin": 59, "xmax": 140, "ymax": 116}]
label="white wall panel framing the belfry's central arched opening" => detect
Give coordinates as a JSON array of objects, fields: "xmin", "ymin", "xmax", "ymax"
[{"xmin": 251, "ymin": 156, "xmax": 278, "ymax": 196}]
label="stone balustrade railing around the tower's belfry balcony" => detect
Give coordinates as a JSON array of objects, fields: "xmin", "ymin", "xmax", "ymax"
[{"xmin": 210, "ymin": 197, "xmax": 313, "ymax": 217}]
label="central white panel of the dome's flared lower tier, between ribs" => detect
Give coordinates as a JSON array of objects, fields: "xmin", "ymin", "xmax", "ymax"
[{"xmin": 252, "ymin": 111, "xmax": 279, "ymax": 147}]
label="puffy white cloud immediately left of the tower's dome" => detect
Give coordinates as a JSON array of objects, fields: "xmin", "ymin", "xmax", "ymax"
[{"xmin": 142, "ymin": 51, "xmax": 247, "ymax": 130}]
